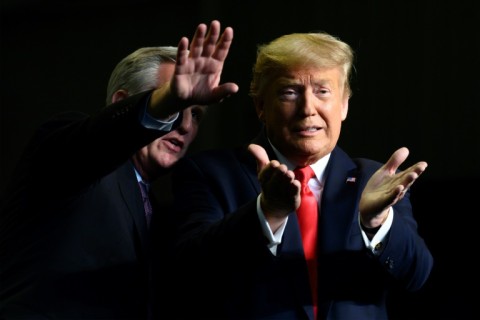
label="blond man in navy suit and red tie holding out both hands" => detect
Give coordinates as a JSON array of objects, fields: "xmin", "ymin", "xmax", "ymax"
[{"xmin": 172, "ymin": 33, "xmax": 433, "ymax": 320}]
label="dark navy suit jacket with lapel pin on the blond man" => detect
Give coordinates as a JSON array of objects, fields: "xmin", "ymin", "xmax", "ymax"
[{"xmin": 173, "ymin": 133, "xmax": 433, "ymax": 320}]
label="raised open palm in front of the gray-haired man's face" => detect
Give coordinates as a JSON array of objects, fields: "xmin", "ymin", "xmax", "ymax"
[{"xmin": 150, "ymin": 20, "xmax": 238, "ymax": 118}]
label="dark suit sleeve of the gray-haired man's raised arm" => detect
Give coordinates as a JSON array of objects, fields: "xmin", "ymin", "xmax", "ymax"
[{"xmin": 20, "ymin": 91, "xmax": 174, "ymax": 193}]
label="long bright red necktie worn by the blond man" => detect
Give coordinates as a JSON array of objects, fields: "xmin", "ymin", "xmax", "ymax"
[{"xmin": 294, "ymin": 166, "xmax": 318, "ymax": 319}]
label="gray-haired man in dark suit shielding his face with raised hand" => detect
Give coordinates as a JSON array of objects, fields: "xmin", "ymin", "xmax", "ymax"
[{"xmin": 0, "ymin": 21, "xmax": 238, "ymax": 320}]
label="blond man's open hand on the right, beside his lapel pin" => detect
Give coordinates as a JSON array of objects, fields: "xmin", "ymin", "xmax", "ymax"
[{"xmin": 359, "ymin": 147, "xmax": 427, "ymax": 228}]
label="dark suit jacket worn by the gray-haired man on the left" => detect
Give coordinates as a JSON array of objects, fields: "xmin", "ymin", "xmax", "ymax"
[{"xmin": 0, "ymin": 94, "xmax": 176, "ymax": 320}]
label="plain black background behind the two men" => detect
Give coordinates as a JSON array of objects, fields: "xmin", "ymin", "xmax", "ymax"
[{"xmin": 0, "ymin": 0, "xmax": 480, "ymax": 319}]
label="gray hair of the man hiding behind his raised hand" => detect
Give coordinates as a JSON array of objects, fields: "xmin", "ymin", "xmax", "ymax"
[{"xmin": 106, "ymin": 46, "xmax": 177, "ymax": 105}]
